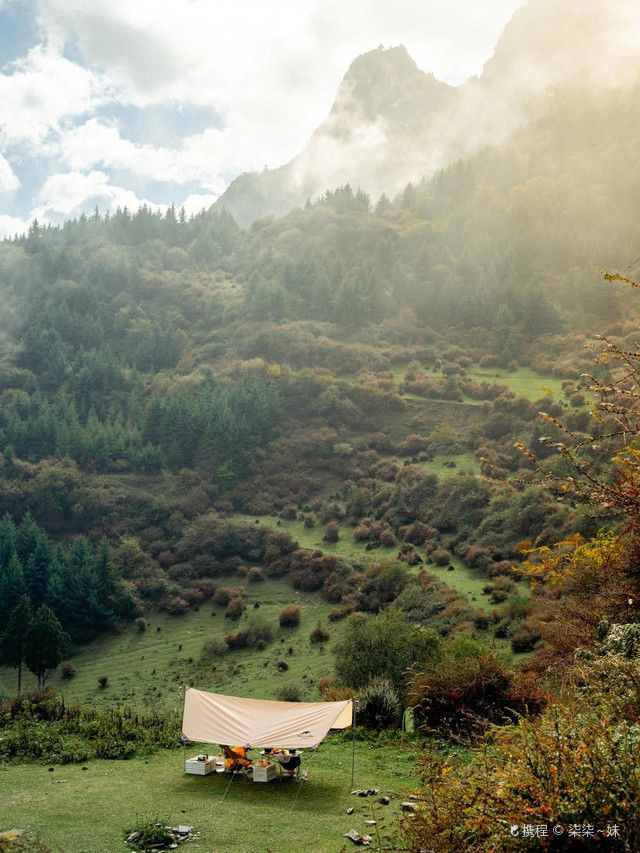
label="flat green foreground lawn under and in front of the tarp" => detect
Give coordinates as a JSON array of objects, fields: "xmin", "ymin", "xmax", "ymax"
[{"xmin": 0, "ymin": 734, "xmax": 416, "ymax": 853}]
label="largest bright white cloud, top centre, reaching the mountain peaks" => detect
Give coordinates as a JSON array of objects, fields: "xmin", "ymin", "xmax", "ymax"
[{"xmin": 39, "ymin": 0, "xmax": 522, "ymax": 171}]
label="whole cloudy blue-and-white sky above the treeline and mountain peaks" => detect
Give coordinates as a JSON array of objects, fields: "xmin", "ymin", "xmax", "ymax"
[{"xmin": 0, "ymin": 0, "xmax": 522, "ymax": 237}]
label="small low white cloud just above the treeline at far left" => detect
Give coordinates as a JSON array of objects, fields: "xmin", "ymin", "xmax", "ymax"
[{"xmin": 31, "ymin": 171, "xmax": 167, "ymax": 222}]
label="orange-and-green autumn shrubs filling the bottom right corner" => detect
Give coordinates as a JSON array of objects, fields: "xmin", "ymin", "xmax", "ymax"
[{"xmin": 402, "ymin": 656, "xmax": 640, "ymax": 853}]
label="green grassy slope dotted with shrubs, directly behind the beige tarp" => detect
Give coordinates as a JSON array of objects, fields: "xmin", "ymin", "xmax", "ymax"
[{"xmin": 0, "ymin": 578, "xmax": 342, "ymax": 711}]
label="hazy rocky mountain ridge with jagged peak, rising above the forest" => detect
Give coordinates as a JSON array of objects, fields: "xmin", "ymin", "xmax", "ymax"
[{"xmin": 212, "ymin": 0, "xmax": 640, "ymax": 225}]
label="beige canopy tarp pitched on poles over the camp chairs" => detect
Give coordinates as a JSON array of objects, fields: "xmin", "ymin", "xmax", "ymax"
[{"xmin": 182, "ymin": 687, "xmax": 353, "ymax": 749}]
